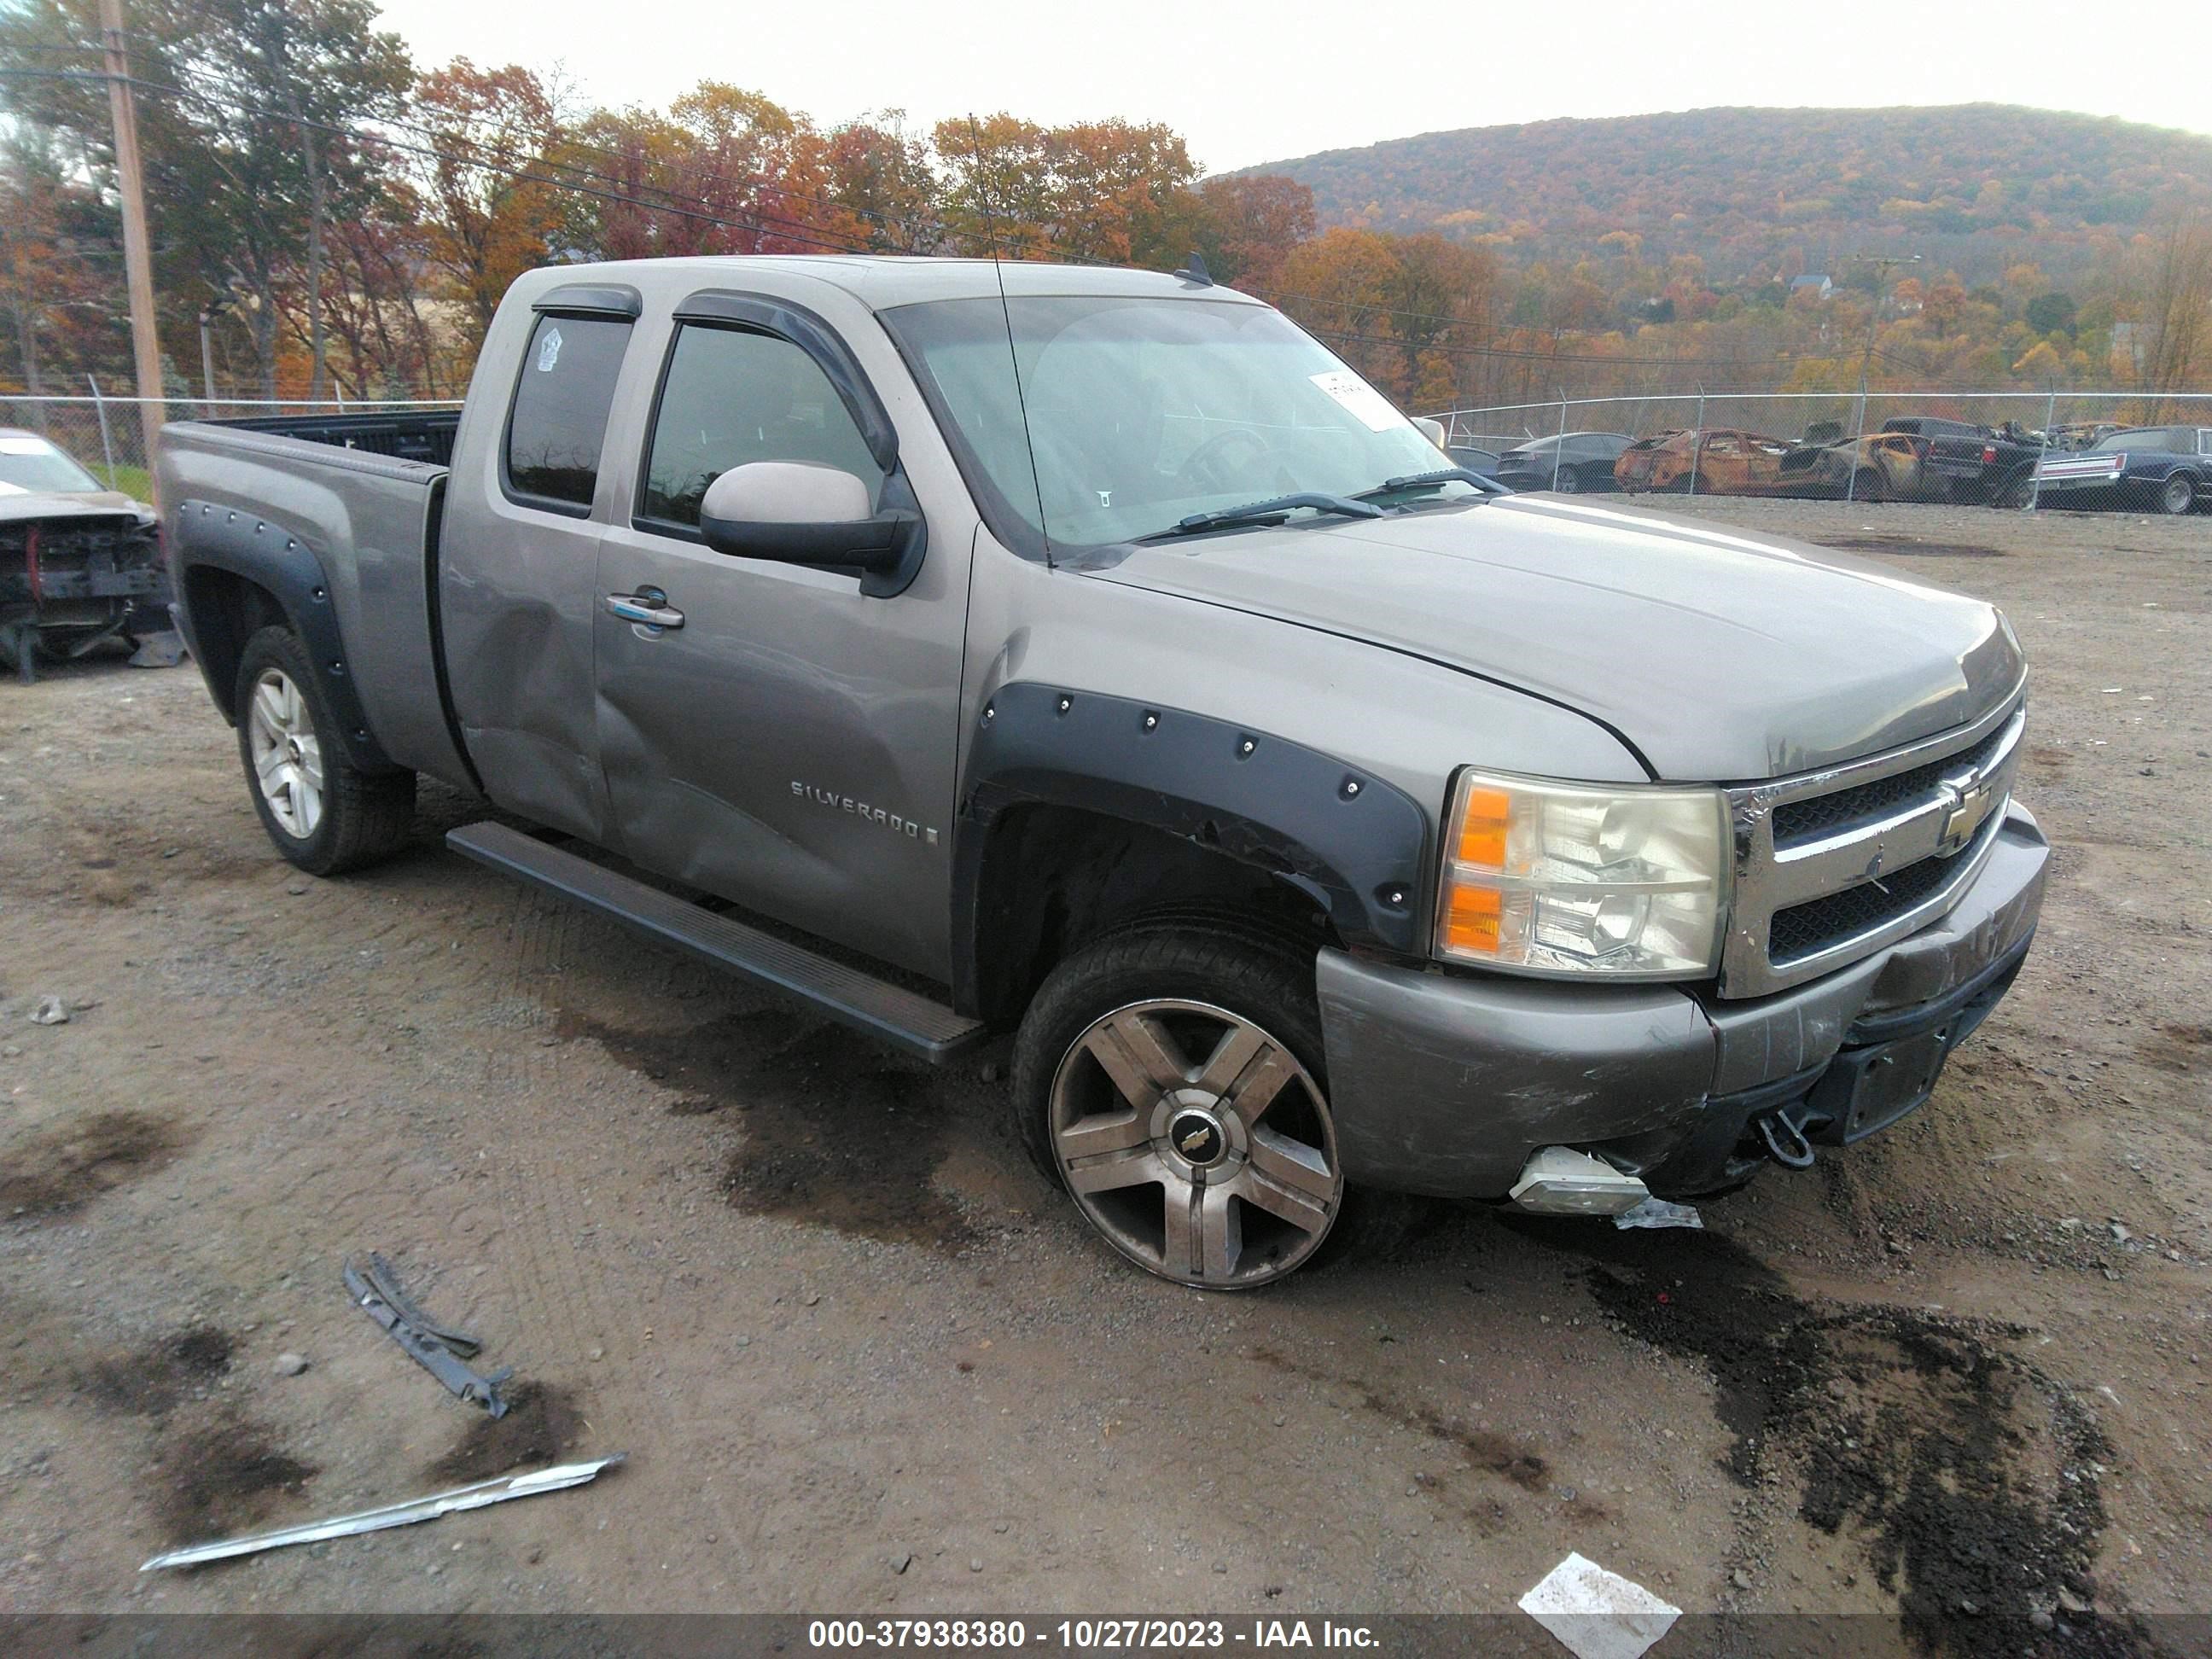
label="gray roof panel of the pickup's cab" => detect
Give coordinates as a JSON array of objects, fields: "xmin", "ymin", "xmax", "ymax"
[{"xmin": 515, "ymin": 254, "xmax": 1260, "ymax": 311}]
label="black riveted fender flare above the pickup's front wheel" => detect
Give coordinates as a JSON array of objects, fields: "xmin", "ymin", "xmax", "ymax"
[{"xmin": 953, "ymin": 681, "xmax": 1434, "ymax": 1022}]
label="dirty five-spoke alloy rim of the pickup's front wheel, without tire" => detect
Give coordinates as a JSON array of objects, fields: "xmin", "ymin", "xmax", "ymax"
[{"xmin": 1051, "ymin": 1000, "xmax": 1345, "ymax": 1289}]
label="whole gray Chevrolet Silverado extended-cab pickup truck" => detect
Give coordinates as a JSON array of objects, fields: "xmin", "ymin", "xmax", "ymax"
[{"xmin": 160, "ymin": 259, "xmax": 2048, "ymax": 1289}]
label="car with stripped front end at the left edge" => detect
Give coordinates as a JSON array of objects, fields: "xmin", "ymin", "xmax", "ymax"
[{"xmin": 0, "ymin": 427, "xmax": 168, "ymax": 684}]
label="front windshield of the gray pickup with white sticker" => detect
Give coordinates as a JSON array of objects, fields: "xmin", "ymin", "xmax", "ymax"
[{"xmin": 882, "ymin": 296, "xmax": 1477, "ymax": 553}]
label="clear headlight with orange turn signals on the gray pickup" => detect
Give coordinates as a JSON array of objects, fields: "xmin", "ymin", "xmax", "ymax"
[{"xmin": 1435, "ymin": 770, "xmax": 1727, "ymax": 980}]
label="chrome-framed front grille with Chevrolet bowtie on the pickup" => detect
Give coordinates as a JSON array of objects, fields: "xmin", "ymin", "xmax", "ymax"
[{"xmin": 1721, "ymin": 695, "xmax": 2026, "ymax": 998}]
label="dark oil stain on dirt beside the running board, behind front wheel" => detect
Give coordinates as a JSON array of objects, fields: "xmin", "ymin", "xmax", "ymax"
[{"xmin": 560, "ymin": 1009, "xmax": 973, "ymax": 1252}]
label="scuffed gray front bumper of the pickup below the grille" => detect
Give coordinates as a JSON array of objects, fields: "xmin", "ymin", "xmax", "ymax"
[{"xmin": 1318, "ymin": 805, "xmax": 2051, "ymax": 1199}]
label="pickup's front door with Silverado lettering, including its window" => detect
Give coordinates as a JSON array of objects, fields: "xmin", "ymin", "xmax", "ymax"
[{"xmin": 595, "ymin": 296, "xmax": 973, "ymax": 980}]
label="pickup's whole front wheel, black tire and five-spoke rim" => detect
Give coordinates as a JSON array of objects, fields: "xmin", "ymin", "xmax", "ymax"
[{"xmin": 1011, "ymin": 918, "xmax": 1409, "ymax": 1289}]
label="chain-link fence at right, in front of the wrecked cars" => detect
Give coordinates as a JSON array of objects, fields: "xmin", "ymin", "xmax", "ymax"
[{"xmin": 1431, "ymin": 392, "xmax": 2212, "ymax": 504}]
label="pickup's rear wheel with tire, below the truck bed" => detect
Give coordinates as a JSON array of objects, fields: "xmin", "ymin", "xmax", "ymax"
[{"xmin": 232, "ymin": 626, "xmax": 414, "ymax": 876}]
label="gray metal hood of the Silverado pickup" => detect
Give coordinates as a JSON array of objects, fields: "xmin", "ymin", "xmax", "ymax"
[{"xmin": 1091, "ymin": 498, "xmax": 2022, "ymax": 783}]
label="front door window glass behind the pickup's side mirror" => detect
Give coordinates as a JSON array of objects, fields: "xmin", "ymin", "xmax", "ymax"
[{"xmin": 639, "ymin": 323, "xmax": 882, "ymax": 527}]
